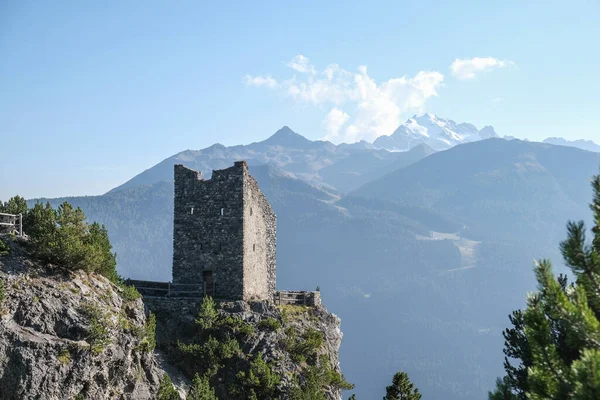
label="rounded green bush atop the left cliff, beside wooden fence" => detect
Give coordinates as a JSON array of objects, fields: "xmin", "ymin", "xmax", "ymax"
[{"xmin": 24, "ymin": 202, "xmax": 119, "ymax": 282}]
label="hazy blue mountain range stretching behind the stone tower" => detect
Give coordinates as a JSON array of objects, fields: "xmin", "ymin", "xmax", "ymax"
[{"xmin": 24, "ymin": 120, "xmax": 600, "ymax": 400}]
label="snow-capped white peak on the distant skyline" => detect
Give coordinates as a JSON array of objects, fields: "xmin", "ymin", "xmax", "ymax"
[{"xmin": 373, "ymin": 113, "xmax": 498, "ymax": 151}]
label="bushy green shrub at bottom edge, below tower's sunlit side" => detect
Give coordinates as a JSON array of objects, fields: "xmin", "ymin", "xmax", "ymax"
[{"xmin": 236, "ymin": 353, "xmax": 281, "ymax": 400}]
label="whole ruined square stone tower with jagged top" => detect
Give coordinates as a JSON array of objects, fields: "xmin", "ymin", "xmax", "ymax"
[{"xmin": 173, "ymin": 161, "xmax": 276, "ymax": 301}]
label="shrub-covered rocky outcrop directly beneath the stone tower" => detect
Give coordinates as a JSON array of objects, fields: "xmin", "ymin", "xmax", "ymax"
[{"xmin": 145, "ymin": 298, "xmax": 352, "ymax": 400}]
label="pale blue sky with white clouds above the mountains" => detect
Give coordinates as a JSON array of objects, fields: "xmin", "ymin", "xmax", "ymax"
[{"xmin": 0, "ymin": 0, "xmax": 600, "ymax": 199}]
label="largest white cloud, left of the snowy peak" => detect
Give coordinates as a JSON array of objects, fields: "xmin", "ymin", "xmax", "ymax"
[{"xmin": 246, "ymin": 55, "xmax": 444, "ymax": 142}]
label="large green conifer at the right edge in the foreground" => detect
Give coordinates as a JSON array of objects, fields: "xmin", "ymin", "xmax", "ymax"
[{"xmin": 489, "ymin": 170, "xmax": 600, "ymax": 400}]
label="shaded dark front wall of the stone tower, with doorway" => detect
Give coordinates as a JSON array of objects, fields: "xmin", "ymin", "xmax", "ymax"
[{"xmin": 173, "ymin": 164, "xmax": 247, "ymax": 300}]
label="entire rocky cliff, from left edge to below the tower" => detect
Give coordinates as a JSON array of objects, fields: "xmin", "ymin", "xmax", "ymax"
[{"xmin": 0, "ymin": 235, "xmax": 351, "ymax": 400}]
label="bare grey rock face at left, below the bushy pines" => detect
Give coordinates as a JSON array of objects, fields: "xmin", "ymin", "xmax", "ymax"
[{"xmin": 0, "ymin": 239, "xmax": 163, "ymax": 400}]
